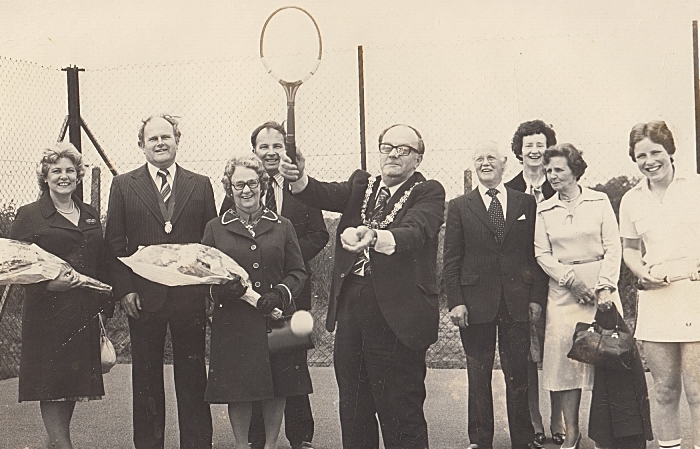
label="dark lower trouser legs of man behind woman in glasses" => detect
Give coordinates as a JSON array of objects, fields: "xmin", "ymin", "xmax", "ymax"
[{"xmin": 248, "ymin": 388, "xmax": 314, "ymax": 448}]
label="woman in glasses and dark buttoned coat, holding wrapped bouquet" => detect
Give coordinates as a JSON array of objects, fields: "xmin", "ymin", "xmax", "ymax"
[{"xmin": 202, "ymin": 155, "xmax": 311, "ymax": 449}]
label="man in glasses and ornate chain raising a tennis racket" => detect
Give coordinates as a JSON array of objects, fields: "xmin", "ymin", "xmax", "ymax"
[{"xmin": 280, "ymin": 125, "xmax": 445, "ymax": 449}]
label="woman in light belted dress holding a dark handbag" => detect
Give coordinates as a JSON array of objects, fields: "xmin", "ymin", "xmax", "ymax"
[{"xmin": 535, "ymin": 143, "xmax": 622, "ymax": 448}]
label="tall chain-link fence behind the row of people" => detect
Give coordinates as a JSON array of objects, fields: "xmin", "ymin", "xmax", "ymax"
[{"xmin": 0, "ymin": 28, "xmax": 694, "ymax": 378}]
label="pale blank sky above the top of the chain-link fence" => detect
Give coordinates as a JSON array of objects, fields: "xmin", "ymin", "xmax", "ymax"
[{"xmin": 0, "ymin": 0, "xmax": 700, "ymax": 68}]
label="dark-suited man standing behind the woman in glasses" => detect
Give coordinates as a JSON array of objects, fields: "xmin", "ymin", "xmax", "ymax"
[{"xmin": 219, "ymin": 122, "xmax": 328, "ymax": 449}]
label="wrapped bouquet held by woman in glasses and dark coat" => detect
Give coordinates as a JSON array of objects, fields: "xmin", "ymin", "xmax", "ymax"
[{"xmin": 119, "ymin": 243, "xmax": 260, "ymax": 307}]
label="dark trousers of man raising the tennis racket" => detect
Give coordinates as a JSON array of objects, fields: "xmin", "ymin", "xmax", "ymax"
[{"xmin": 334, "ymin": 275, "xmax": 428, "ymax": 449}]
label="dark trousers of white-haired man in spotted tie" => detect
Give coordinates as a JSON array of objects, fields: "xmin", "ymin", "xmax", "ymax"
[{"xmin": 460, "ymin": 298, "xmax": 535, "ymax": 448}]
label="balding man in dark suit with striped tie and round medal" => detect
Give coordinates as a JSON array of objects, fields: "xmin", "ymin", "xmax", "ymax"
[{"xmin": 106, "ymin": 115, "xmax": 216, "ymax": 449}]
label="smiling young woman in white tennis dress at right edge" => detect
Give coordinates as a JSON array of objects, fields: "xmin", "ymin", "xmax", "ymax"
[{"xmin": 620, "ymin": 121, "xmax": 700, "ymax": 448}]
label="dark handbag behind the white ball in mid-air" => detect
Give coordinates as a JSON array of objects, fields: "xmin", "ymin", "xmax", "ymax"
[{"xmin": 267, "ymin": 298, "xmax": 314, "ymax": 355}]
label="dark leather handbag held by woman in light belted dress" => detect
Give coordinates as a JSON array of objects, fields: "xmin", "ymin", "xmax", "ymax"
[{"xmin": 566, "ymin": 304, "xmax": 635, "ymax": 370}]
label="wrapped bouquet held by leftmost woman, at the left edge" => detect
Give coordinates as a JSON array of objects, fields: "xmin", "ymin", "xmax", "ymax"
[{"xmin": 0, "ymin": 238, "xmax": 112, "ymax": 293}]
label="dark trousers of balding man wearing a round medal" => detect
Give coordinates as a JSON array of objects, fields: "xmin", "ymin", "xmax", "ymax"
[{"xmin": 129, "ymin": 302, "xmax": 212, "ymax": 449}]
